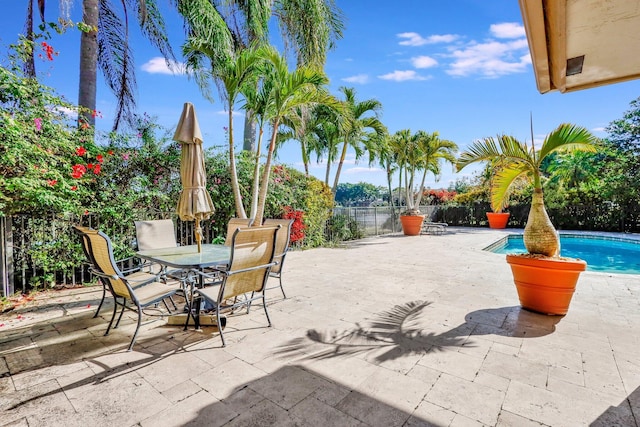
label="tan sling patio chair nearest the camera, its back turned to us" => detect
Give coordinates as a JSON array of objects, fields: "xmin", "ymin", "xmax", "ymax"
[{"xmin": 187, "ymin": 226, "xmax": 280, "ymax": 347}]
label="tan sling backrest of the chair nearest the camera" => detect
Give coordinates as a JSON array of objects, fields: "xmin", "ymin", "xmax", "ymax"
[{"xmin": 219, "ymin": 227, "xmax": 279, "ymax": 301}]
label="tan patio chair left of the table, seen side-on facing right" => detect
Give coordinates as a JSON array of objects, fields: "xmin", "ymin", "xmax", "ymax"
[{"xmin": 86, "ymin": 231, "xmax": 181, "ymax": 351}]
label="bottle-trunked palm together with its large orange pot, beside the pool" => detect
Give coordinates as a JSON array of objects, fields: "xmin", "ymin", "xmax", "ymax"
[{"xmin": 457, "ymin": 124, "xmax": 598, "ymax": 315}]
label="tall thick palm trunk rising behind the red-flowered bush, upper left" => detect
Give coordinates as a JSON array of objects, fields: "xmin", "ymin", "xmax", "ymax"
[{"xmin": 78, "ymin": 0, "xmax": 99, "ymax": 127}]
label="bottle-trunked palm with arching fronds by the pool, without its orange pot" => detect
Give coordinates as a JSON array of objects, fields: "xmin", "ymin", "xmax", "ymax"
[{"xmin": 457, "ymin": 123, "xmax": 598, "ymax": 257}]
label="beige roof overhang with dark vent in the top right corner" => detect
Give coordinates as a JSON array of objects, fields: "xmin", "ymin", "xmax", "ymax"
[{"xmin": 519, "ymin": 0, "xmax": 640, "ymax": 93}]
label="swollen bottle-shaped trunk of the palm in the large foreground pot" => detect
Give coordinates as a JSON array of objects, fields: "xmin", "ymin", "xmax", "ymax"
[{"xmin": 524, "ymin": 188, "xmax": 560, "ymax": 257}]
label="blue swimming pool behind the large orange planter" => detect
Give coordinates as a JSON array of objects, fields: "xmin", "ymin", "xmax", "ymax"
[{"xmin": 484, "ymin": 234, "xmax": 640, "ymax": 274}]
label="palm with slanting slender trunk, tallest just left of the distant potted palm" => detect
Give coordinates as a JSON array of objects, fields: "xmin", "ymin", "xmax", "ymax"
[{"xmin": 331, "ymin": 86, "xmax": 386, "ymax": 196}]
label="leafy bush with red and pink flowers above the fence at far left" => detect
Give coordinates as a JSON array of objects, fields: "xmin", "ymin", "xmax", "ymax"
[{"xmin": 0, "ymin": 36, "xmax": 106, "ymax": 215}]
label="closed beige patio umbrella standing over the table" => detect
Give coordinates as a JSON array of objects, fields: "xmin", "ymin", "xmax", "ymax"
[{"xmin": 173, "ymin": 102, "xmax": 215, "ymax": 252}]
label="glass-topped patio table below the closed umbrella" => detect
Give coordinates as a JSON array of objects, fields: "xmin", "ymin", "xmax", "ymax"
[{"xmin": 137, "ymin": 244, "xmax": 231, "ymax": 330}]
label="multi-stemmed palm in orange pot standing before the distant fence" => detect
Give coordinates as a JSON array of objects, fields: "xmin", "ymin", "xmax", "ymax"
[{"xmin": 392, "ymin": 129, "xmax": 458, "ymax": 236}]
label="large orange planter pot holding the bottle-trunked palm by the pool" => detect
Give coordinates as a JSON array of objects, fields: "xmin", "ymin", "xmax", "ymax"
[{"xmin": 507, "ymin": 255, "xmax": 587, "ymax": 315}]
